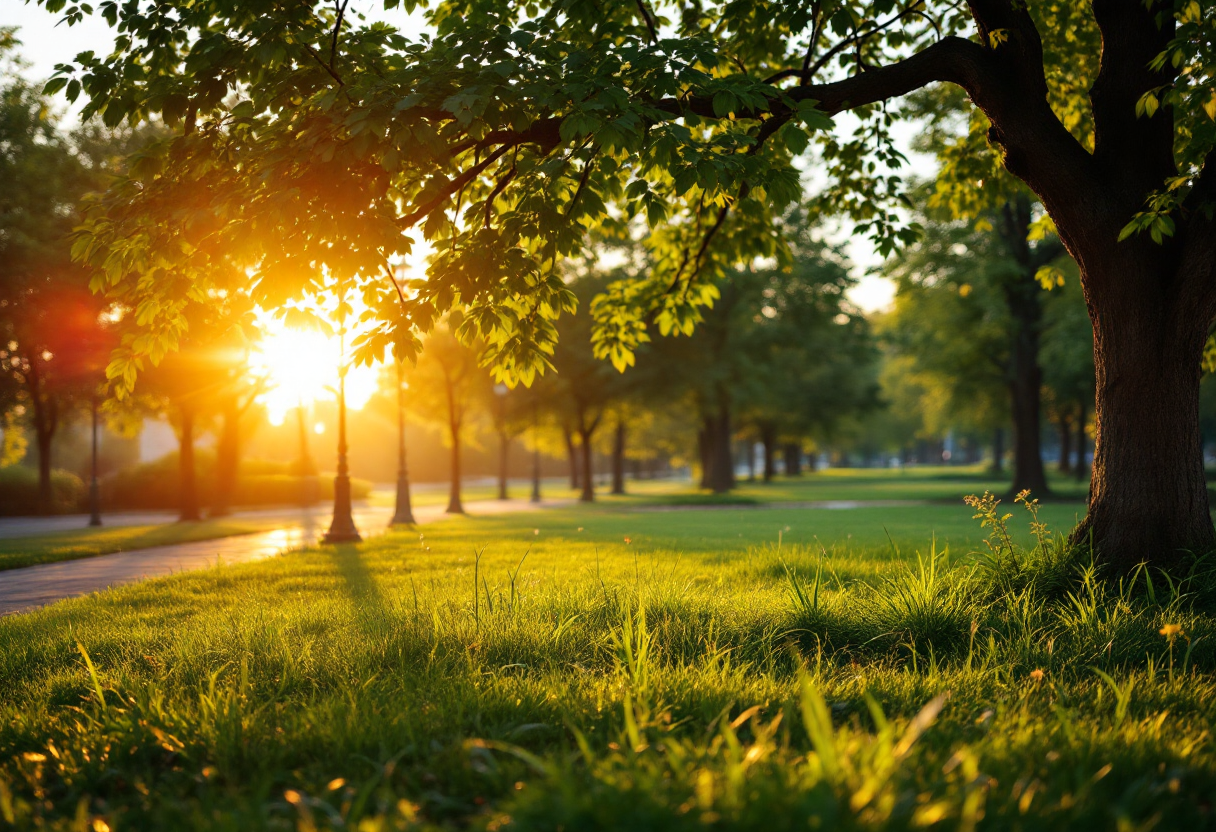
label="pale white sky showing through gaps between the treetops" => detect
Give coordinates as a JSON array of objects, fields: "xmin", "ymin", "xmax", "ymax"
[{"xmin": 0, "ymin": 0, "xmax": 933, "ymax": 313}]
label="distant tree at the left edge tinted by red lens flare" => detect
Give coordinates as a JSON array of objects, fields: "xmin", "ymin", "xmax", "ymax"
[{"xmin": 0, "ymin": 40, "xmax": 111, "ymax": 507}]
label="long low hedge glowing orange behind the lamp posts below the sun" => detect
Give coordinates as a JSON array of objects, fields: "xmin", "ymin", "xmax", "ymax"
[{"xmin": 101, "ymin": 450, "xmax": 372, "ymax": 511}]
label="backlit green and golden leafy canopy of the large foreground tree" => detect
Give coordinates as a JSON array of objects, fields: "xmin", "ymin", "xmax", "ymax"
[{"xmin": 41, "ymin": 0, "xmax": 1214, "ymax": 383}]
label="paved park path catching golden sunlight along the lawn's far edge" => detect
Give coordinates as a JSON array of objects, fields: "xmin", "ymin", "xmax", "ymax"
[{"xmin": 0, "ymin": 500, "xmax": 569, "ymax": 615}]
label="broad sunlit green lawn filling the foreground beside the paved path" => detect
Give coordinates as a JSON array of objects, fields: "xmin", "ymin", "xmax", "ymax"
[{"xmin": 0, "ymin": 484, "xmax": 1216, "ymax": 832}]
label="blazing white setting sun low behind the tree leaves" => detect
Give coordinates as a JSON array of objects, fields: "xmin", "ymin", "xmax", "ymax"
[{"xmin": 250, "ymin": 316, "xmax": 379, "ymax": 426}]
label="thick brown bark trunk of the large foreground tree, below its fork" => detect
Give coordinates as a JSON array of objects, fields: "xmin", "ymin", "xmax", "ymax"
[{"xmin": 1073, "ymin": 289, "xmax": 1216, "ymax": 573}]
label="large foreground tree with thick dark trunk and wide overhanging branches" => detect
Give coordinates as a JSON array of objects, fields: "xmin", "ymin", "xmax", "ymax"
[{"xmin": 52, "ymin": 0, "xmax": 1216, "ymax": 569}]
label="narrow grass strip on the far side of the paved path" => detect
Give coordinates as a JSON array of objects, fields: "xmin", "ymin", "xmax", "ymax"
[{"xmin": 0, "ymin": 519, "xmax": 271, "ymax": 571}]
